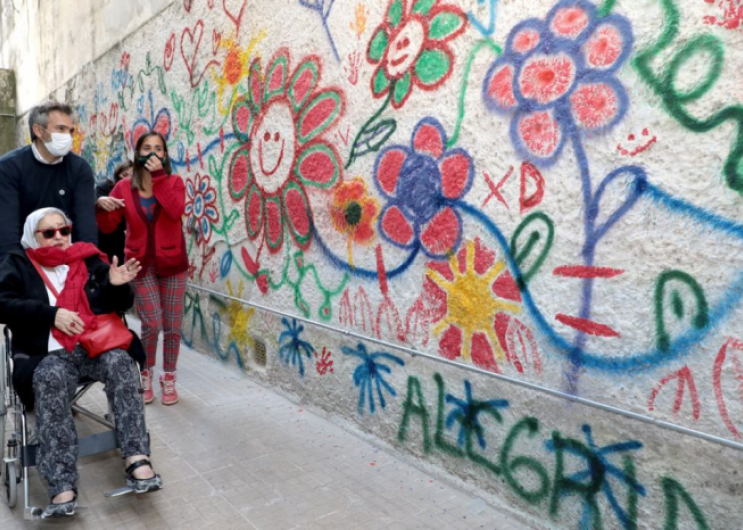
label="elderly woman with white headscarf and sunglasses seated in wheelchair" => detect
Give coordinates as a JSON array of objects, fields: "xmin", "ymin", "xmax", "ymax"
[{"xmin": 0, "ymin": 208, "xmax": 162, "ymax": 518}]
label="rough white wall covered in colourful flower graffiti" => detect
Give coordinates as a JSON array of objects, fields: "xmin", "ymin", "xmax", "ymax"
[{"xmin": 4, "ymin": 0, "xmax": 743, "ymax": 529}]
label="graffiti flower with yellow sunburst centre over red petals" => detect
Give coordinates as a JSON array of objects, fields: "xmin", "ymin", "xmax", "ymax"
[{"xmin": 425, "ymin": 239, "xmax": 521, "ymax": 372}]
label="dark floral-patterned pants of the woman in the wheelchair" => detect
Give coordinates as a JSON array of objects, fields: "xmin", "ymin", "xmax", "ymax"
[{"xmin": 33, "ymin": 345, "xmax": 150, "ymax": 498}]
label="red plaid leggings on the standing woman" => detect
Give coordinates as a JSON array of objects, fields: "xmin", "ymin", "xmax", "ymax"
[{"xmin": 132, "ymin": 267, "xmax": 186, "ymax": 372}]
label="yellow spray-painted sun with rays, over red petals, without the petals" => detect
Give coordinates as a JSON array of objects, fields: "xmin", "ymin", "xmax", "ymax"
[{"xmin": 426, "ymin": 241, "xmax": 521, "ymax": 360}]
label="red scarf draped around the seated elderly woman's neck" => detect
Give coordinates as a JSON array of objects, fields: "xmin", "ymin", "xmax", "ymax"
[{"xmin": 26, "ymin": 243, "xmax": 108, "ymax": 352}]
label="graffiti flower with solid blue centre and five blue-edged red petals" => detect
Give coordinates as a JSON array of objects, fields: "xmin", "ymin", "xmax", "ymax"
[{"xmin": 374, "ymin": 118, "xmax": 475, "ymax": 259}]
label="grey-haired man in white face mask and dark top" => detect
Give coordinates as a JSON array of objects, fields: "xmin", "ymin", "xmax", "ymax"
[{"xmin": 0, "ymin": 101, "xmax": 98, "ymax": 257}]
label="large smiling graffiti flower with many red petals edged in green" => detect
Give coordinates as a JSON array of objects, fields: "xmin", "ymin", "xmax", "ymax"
[{"xmin": 229, "ymin": 49, "xmax": 345, "ymax": 252}]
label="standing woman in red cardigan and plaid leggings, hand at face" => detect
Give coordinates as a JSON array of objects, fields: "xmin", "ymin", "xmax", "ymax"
[{"xmin": 97, "ymin": 131, "xmax": 188, "ymax": 405}]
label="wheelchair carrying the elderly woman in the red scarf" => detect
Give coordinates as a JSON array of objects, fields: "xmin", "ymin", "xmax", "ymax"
[{"xmin": 0, "ymin": 326, "xmax": 149, "ymax": 521}]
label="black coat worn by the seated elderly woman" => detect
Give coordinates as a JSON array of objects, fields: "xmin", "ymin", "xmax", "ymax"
[{"xmin": 0, "ymin": 250, "xmax": 134, "ymax": 407}]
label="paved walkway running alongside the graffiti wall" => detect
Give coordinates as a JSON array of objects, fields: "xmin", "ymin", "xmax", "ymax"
[{"xmin": 0, "ymin": 324, "xmax": 526, "ymax": 530}]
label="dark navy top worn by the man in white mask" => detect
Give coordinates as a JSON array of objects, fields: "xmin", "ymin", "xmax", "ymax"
[{"xmin": 0, "ymin": 145, "xmax": 98, "ymax": 257}]
